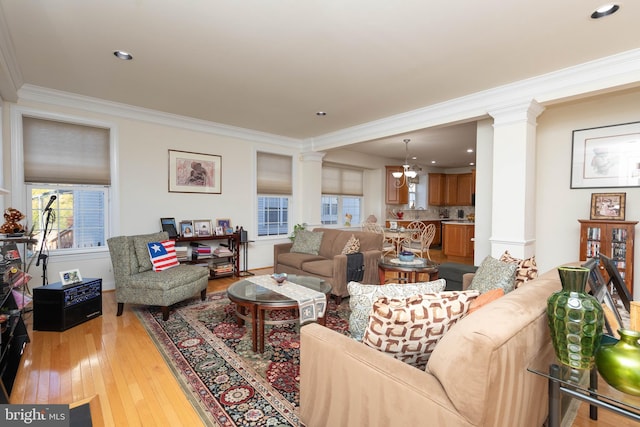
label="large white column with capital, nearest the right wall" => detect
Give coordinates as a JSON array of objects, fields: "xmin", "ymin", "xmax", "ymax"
[{"xmin": 489, "ymin": 100, "xmax": 544, "ymax": 258}]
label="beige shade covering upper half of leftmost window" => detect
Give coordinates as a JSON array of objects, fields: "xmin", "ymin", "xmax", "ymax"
[{"xmin": 22, "ymin": 117, "xmax": 111, "ymax": 185}]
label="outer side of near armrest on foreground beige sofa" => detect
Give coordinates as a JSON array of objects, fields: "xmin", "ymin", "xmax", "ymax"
[{"xmin": 300, "ymin": 323, "xmax": 469, "ymax": 427}]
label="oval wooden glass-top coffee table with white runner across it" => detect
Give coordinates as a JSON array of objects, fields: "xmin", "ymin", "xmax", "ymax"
[{"xmin": 227, "ymin": 275, "xmax": 331, "ymax": 353}]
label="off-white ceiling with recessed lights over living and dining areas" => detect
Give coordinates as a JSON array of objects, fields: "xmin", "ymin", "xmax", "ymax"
[{"xmin": 0, "ymin": 0, "xmax": 640, "ymax": 167}]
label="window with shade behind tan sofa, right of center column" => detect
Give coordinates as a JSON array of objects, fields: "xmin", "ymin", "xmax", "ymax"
[{"xmin": 320, "ymin": 164, "xmax": 363, "ymax": 225}]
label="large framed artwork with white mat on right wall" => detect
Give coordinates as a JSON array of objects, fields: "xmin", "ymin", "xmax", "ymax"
[{"xmin": 571, "ymin": 122, "xmax": 640, "ymax": 188}]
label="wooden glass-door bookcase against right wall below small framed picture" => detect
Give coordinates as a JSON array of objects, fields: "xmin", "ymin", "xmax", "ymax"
[{"xmin": 578, "ymin": 219, "xmax": 638, "ymax": 295}]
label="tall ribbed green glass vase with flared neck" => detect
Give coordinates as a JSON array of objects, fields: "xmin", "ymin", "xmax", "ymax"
[{"xmin": 547, "ymin": 266, "xmax": 604, "ymax": 369}]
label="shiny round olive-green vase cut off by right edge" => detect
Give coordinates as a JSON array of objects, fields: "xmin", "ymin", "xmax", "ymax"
[{"xmin": 596, "ymin": 329, "xmax": 640, "ymax": 396}]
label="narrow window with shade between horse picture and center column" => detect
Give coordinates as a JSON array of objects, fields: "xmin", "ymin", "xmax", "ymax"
[{"xmin": 256, "ymin": 152, "xmax": 292, "ymax": 236}]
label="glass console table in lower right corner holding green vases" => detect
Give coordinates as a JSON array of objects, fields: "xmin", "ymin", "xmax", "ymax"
[{"xmin": 527, "ymin": 352, "xmax": 640, "ymax": 427}]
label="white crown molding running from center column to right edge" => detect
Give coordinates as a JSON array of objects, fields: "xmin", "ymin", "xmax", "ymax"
[{"xmin": 305, "ymin": 49, "xmax": 640, "ymax": 151}]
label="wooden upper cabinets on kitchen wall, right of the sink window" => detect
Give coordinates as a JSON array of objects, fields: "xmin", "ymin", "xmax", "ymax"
[{"xmin": 429, "ymin": 172, "xmax": 475, "ymax": 206}]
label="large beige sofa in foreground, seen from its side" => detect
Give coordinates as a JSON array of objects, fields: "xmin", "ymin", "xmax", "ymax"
[{"xmin": 300, "ymin": 269, "xmax": 561, "ymax": 427}]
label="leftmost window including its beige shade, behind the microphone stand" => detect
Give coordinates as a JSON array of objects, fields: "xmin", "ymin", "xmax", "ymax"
[{"xmin": 22, "ymin": 116, "xmax": 111, "ymax": 252}]
